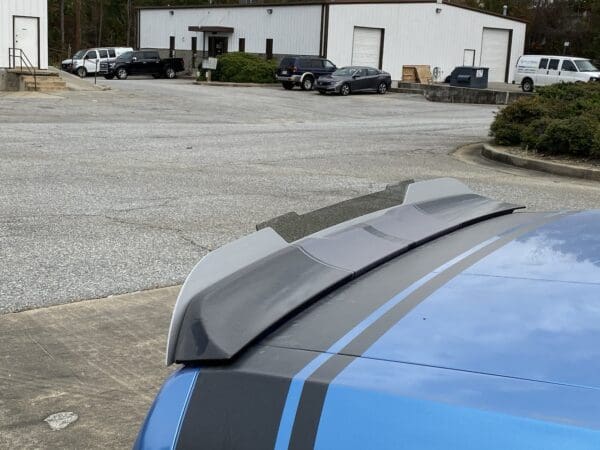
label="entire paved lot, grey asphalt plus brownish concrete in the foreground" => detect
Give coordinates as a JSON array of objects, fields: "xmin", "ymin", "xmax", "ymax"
[{"xmin": 0, "ymin": 78, "xmax": 600, "ymax": 448}]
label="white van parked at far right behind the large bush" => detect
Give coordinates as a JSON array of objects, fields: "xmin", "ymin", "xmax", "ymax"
[{"xmin": 513, "ymin": 55, "xmax": 600, "ymax": 92}]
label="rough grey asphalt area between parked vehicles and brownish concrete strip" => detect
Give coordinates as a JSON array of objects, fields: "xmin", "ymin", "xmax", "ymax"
[{"xmin": 0, "ymin": 78, "xmax": 600, "ymax": 313}]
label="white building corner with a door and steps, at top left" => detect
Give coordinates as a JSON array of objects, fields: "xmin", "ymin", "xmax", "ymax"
[{"xmin": 0, "ymin": 0, "xmax": 48, "ymax": 69}]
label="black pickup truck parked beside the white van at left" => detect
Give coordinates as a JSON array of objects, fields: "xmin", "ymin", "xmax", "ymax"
[{"xmin": 104, "ymin": 50, "xmax": 185, "ymax": 80}]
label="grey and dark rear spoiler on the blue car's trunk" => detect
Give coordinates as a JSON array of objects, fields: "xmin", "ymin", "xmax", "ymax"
[{"xmin": 167, "ymin": 178, "xmax": 522, "ymax": 364}]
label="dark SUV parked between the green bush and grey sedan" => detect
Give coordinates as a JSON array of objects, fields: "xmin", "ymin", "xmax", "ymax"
[{"xmin": 277, "ymin": 56, "xmax": 336, "ymax": 91}]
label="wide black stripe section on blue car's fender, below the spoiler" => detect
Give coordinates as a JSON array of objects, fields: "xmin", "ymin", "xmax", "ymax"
[{"xmin": 176, "ymin": 346, "xmax": 318, "ymax": 450}]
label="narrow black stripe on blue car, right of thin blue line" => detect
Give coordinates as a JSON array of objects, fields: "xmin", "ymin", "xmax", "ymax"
[{"xmin": 289, "ymin": 212, "xmax": 558, "ymax": 450}]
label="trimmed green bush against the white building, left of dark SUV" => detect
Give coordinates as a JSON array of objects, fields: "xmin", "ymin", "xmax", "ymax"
[{"xmin": 212, "ymin": 53, "xmax": 277, "ymax": 83}]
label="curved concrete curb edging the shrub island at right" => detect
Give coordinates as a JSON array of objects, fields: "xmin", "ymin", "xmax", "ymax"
[{"xmin": 481, "ymin": 143, "xmax": 600, "ymax": 181}]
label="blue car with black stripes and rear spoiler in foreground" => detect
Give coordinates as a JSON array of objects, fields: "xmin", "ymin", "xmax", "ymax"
[{"xmin": 135, "ymin": 179, "xmax": 600, "ymax": 450}]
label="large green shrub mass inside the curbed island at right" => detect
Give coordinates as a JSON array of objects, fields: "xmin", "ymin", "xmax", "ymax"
[{"xmin": 490, "ymin": 83, "xmax": 600, "ymax": 159}]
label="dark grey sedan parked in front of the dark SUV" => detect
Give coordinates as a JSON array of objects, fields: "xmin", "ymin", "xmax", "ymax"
[{"xmin": 316, "ymin": 66, "xmax": 392, "ymax": 95}]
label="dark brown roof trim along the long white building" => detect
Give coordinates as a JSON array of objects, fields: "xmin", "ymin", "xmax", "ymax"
[{"xmin": 136, "ymin": 0, "xmax": 529, "ymax": 24}]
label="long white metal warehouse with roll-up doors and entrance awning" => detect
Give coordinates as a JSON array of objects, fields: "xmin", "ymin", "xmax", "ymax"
[{"xmin": 138, "ymin": 0, "xmax": 526, "ymax": 82}]
